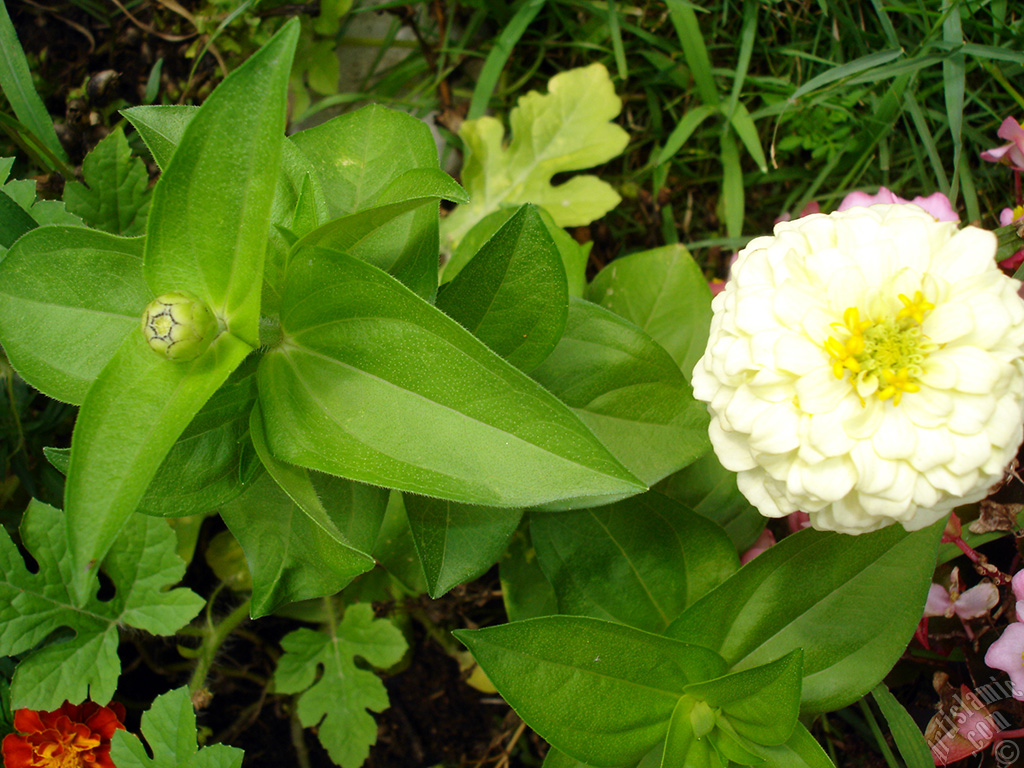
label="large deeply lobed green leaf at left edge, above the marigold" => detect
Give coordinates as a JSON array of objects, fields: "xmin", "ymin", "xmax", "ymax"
[{"xmin": 0, "ymin": 501, "xmax": 204, "ymax": 710}]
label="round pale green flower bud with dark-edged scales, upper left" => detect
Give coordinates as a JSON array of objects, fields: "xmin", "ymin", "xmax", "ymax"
[{"xmin": 142, "ymin": 291, "xmax": 219, "ymax": 362}]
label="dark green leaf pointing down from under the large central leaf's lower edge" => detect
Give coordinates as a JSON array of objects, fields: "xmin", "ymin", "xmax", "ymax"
[{"xmin": 406, "ymin": 495, "xmax": 522, "ymax": 599}]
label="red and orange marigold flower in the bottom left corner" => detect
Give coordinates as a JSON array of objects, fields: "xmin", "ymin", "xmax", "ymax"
[{"xmin": 3, "ymin": 701, "xmax": 125, "ymax": 768}]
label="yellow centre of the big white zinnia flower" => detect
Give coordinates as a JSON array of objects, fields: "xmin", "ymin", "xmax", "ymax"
[{"xmin": 824, "ymin": 291, "xmax": 935, "ymax": 406}]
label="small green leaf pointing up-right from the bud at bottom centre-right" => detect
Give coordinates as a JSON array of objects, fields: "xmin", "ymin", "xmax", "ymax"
[{"xmin": 685, "ymin": 648, "xmax": 803, "ymax": 746}]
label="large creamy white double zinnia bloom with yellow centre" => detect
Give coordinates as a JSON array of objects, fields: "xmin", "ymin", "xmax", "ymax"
[{"xmin": 693, "ymin": 205, "xmax": 1024, "ymax": 534}]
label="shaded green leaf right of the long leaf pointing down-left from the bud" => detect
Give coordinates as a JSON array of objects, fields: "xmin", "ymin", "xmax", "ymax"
[{"xmin": 139, "ymin": 355, "xmax": 258, "ymax": 517}]
